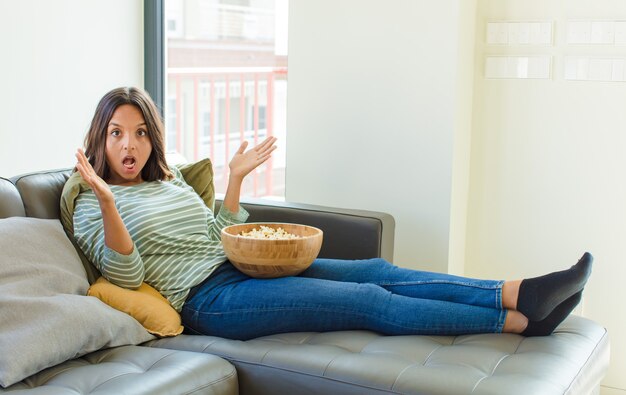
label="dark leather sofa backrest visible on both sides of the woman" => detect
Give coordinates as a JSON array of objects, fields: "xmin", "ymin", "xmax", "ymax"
[{"xmin": 0, "ymin": 169, "xmax": 395, "ymax": 264}]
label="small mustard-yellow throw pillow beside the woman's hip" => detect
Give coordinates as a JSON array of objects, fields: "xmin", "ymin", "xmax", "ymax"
[{"xmin": 88, "ymin": 277, "xmax": 183, "ymax": 337}]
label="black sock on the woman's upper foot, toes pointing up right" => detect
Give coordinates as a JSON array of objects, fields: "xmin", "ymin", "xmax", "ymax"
[{"xmin": 517, "ymin": 252, "xmax": 593, "ymax": 321}]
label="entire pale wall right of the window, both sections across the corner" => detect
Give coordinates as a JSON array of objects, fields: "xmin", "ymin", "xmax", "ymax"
[{"xmin": 286, "ymin": 0, "xmax": 626, "ymax": 393}]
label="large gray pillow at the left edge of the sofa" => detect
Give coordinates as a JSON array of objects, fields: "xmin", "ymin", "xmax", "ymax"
[{"xmin": 0, "ymin": 217, "xmax": 154, "ymax": 387}]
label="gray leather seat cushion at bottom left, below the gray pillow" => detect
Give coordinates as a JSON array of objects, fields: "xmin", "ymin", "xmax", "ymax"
[{"xmin": 0, "ymin": 346, "xmax": 238, "ymax": 395}]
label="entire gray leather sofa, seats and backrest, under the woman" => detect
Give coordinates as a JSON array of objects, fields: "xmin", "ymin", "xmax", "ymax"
[{"xmin": 0, "ymin": 170, "xmax": 609, "ymax": 395}]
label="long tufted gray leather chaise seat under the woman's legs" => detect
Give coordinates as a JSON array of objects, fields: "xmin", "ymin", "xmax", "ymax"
[{"xmin": 147, "ymin": 316, "xmax": 609, "ymax": 395}]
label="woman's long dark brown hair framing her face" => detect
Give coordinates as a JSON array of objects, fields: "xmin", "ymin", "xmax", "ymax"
[{"xmin": 85, "ymin": 87, "xmax": 173, "ymax": 181}]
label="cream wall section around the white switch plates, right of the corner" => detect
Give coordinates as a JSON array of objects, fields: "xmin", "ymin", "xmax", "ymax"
[{"xmin": 465, "ymin": 0, "xmax": 626, "ymax": 393}]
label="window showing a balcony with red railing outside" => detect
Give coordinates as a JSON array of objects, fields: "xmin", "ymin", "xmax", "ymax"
[{"xmin": 160, "ymin": 0, "xmax": 288, "ymax": 198}]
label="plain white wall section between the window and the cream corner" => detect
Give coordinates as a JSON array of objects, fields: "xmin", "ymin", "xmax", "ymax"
[{"xmin": 286, "ymin": 0, "xmax": 474, "ymax": 271}]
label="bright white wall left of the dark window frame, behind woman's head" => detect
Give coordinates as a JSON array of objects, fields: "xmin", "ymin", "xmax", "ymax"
[{"xmin": 0, "ymin": 0, "xmax": 143, "ymax": 177}]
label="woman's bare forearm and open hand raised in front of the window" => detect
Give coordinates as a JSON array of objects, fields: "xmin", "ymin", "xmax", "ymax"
[{"xmin": 222, "ymin": 137, "xmax": 276, "ymax": 213}]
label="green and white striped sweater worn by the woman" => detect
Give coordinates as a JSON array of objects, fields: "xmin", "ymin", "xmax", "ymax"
[{"xmin": 74, "ymin": 168, "xmax": 248, "ymax": 311}]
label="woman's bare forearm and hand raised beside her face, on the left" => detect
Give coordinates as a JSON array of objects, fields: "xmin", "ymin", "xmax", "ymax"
[{"xmin": 76, "ymin": 149, "xmax": 134, "ymax": 255}]
